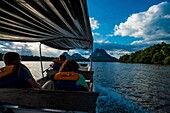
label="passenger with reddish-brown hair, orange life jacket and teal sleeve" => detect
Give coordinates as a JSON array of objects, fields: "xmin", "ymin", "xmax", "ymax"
[{"xmin": 54, "ymin": 60, "xmax": 89, "ymax": 91}]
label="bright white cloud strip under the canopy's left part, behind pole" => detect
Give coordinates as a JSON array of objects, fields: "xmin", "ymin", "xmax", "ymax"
[{"xmin": 0, "ymin": 41, "xmax": 65, "ymax": 57}]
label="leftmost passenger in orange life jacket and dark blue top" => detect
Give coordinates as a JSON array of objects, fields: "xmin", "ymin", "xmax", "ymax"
[{"xmin": 0, "ymin": 52, "xmax": 41, "ymax": 88}]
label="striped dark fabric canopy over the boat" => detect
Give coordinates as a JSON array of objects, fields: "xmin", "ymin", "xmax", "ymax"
[{"xmin": 0, "ymin": 0, "xmax": 93, "ymax": 50}]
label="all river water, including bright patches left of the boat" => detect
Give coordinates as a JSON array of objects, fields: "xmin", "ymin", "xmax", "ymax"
[{"xmin": 0, "ymin": 62, "xmax": 170, "ymax": 113}]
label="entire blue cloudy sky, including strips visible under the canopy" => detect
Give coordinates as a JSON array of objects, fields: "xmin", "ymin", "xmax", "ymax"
[{"xmin": 0, "ymin": 0, "xmax": 170, "ymax": 58}]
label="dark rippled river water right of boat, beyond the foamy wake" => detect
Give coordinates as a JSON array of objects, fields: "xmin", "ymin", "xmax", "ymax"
[{"xmin": 93, "ymin": 62, "xmax": 170, "ymax": 113}]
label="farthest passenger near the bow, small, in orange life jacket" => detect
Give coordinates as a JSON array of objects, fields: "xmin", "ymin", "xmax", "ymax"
[{"xmin": 50, "ymin": 54, "xmax": 66, "ymax": 71}]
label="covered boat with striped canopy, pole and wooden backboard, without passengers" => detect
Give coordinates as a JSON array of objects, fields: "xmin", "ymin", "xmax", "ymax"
[{"xmin": 0, "ymin": 0, "xmax": 99, "ymax": 113}]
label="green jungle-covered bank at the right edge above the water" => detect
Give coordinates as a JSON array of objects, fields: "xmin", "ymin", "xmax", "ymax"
[{"xmin": 119, "ymin": 42, "xmax": 170, "ymax": 64}]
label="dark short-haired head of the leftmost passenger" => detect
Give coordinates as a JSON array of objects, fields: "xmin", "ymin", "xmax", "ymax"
[{"xmin": 2, "ymin": 52, "xmax": 21, "ymax": 65}]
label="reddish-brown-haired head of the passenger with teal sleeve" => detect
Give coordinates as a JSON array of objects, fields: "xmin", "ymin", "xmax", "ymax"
[{"xmin": 59, "ymin": 60, "xmax": 79, "ymax": 72}]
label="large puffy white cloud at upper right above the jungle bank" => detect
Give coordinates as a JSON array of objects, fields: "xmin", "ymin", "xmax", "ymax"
[{"xmin": 114, "ymin": 2, "xmax": 170, "ymax": 44}]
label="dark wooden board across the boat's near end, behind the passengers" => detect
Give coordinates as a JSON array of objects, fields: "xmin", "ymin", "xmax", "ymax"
[{"xmin": 0, "ymin": 88, "xmax": 98, "ymax": 113}]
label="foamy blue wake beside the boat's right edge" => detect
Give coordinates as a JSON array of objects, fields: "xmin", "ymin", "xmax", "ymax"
[{"xmin": 95, "ymin": 84, "xmax": 146, "ymax": 113}]
